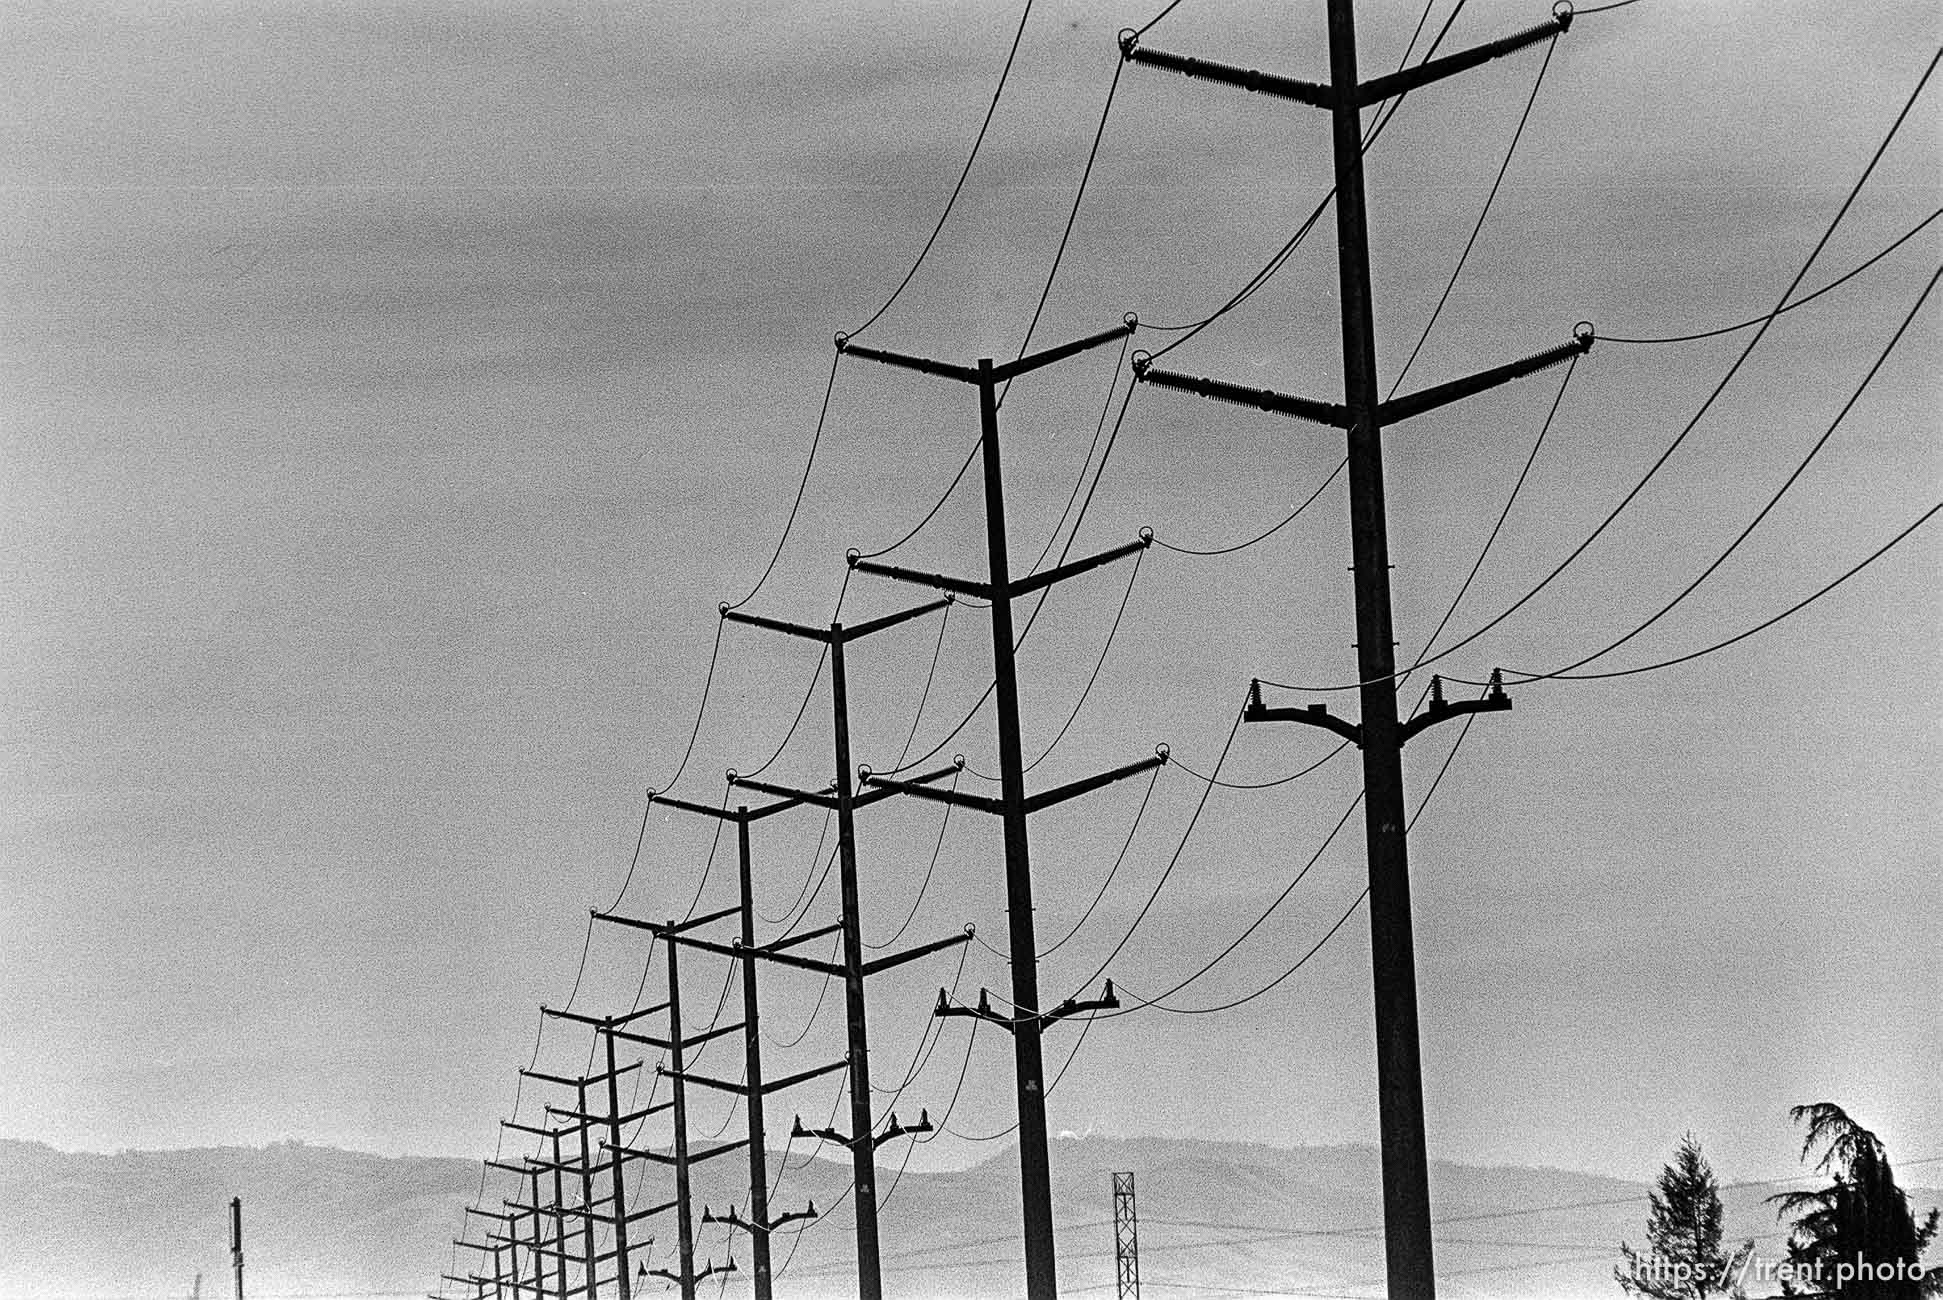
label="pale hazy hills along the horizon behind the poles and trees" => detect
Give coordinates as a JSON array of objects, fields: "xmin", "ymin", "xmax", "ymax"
[{"xmin": 0, "ymin": 1139, "xmax": 1939, "ymax": 1300}]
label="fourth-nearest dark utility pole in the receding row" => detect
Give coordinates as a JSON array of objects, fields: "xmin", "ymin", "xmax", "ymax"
[{"xmin": 595, "ymin": 793, "xmax": 845, "ymax": 1300}]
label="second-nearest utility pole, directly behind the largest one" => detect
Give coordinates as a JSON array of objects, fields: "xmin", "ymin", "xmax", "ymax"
[{"xmin": 837, "ymin": 315, "xmax": 1166, "ymax": 1300}]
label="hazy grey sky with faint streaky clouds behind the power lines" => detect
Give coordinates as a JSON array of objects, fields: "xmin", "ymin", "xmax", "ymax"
[{"xmin": 0, "ymin": 0, "xmax": 1943, "ymax": 1220}]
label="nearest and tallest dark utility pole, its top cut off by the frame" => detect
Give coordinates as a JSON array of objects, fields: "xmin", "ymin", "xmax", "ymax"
[{"xmin": 1121, "ymin": 0, "xmax": 1593, "ymax": 1300}]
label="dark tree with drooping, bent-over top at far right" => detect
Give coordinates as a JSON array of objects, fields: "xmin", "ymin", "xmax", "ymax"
[{"xmin": 1768, "ymin": 1102, "xmax": 1943, "ymax": 1300}]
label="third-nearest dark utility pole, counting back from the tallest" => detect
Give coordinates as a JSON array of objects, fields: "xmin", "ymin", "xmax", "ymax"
[{"xmin": 668, "ymin": 599, "xmax": 972, "ymax": 1300}]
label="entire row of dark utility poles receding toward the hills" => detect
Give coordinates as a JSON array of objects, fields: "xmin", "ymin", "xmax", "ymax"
[{"xmin": 445, "ymin": 0, "xmax": 1593, "ymax": 1300}]
